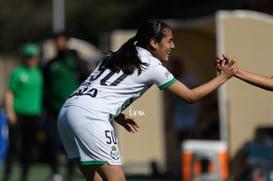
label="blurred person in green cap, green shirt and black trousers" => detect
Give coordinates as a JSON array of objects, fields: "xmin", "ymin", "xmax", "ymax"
[{"xmin": 3, "ymin": 43, "xmax": 43, "ymax": 181}]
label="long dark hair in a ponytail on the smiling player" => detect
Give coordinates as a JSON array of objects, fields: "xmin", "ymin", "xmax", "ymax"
[{"xmin": 103, "ymin": 20, "xmax": 170, "ymax": 74}]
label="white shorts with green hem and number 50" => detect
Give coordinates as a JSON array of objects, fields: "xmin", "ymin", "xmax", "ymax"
[{"xmin": 57, "ymin": 106, "xmax": 121, "ymax": 165}]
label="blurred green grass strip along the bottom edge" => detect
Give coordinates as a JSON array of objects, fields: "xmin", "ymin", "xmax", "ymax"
[{"xmin": 0, "ymin": 163, "xmax": 180, "ymax": 181}]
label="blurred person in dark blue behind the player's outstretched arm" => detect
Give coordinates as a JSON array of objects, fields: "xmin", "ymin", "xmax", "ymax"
[{"xmin": 170, "ymin": 57, "xmax": 200, "ymax": 176}]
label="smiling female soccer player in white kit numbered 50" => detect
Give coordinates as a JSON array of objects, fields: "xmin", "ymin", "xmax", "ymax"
[{"xmin": 58, "ymin": 20, "xmax": 237, "ymax": 181}]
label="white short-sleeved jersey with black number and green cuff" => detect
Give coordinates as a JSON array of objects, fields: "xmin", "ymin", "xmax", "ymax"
[{"xmin": 64, "ymin": 47, "xmax": 176, "ymax": 121}]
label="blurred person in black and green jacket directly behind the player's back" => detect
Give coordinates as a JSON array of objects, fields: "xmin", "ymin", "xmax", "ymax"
[{"xmin": 43, "ymin": 32, "xmax": 89, "ymax": 181}]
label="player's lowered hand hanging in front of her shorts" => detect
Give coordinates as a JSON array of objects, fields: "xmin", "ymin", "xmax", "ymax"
[{"xmin": 115, "ymin": 114, "xmax": 139, "ymax": 133}]
